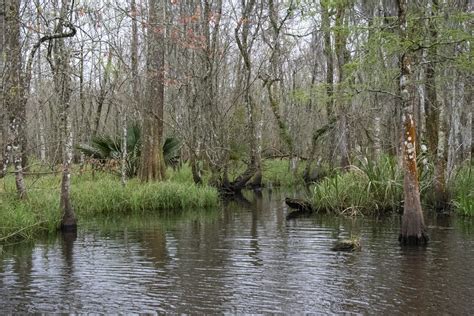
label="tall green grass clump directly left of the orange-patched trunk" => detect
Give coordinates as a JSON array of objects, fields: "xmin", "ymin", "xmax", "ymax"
[{"xmin": 312, "ymin": 157, "xmax": 403, "ymax": 215}]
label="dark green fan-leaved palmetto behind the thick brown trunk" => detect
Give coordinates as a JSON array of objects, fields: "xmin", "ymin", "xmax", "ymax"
[{"xmin": 77, "ymin": 124, "xmax": 181, "ymax": 177}]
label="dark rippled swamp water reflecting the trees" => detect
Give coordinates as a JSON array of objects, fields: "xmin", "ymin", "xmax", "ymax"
[{"xmin": 0, "ymin": 192, "xmax": 474, "ymax": 315}]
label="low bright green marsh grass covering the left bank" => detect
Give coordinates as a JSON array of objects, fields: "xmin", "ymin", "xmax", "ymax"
[{"xmin": 0, "ymin": 173, "xmax": 219, "ymax": 242}]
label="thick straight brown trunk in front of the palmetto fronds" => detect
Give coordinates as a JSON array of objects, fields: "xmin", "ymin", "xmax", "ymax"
[{"xmin": 139, "ymin": 0, "xmax": 165, "ymax": 182}]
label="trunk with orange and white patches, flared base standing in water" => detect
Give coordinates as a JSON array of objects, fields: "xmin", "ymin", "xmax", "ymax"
[{"xmin": 398, "ymin": 0, "xmax": 428, "ymax": 244}]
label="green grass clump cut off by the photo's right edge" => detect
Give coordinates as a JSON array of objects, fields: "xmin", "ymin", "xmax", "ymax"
[{"xmin": 452, "ymin": 166, "xmax": 474, "ymax": 216}]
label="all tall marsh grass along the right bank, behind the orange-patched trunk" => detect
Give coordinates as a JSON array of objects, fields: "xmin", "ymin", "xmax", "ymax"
[{"xmin": 311, "ymin": 156, "xmax": 474, "ymax": 216}]
